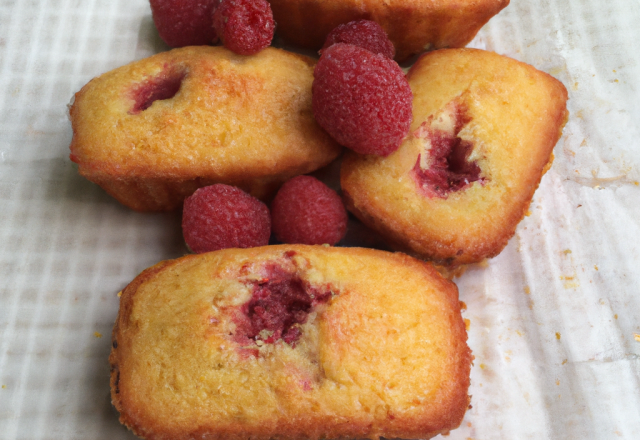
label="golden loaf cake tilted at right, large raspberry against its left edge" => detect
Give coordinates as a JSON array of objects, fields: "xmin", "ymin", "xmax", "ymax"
[{"xmin": 341, "ymin": 49, "xmax": 568, "ymax": 267}]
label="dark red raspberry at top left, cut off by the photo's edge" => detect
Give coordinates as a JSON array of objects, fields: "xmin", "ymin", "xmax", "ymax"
[{"xmin": 150, "ymin": 0, "xmax": 217, "ymax": 47}]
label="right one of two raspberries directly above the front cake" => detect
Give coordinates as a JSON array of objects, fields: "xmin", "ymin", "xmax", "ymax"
[{"xmin": 271, "ymin": 176, "xmax": 347, "ymax": 245}]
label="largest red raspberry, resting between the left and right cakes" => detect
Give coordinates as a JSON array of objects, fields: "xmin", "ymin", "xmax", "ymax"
[{"xmin": 312, "ymin": 43, "xmax": 413, "ymax": 156}]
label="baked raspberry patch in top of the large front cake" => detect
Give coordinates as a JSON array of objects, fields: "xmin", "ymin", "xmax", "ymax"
[{"xmin": 235, "ymin": 264, "xmax": 332, "ymax": 346}]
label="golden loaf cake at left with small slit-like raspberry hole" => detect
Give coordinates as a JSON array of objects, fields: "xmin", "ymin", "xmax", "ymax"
[{"xmin": 70, "ymin": 46, "xmax": 341, "ymax": 211}]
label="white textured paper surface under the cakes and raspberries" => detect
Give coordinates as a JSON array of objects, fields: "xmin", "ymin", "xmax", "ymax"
[{"xmin": 0, "ymin": 0, "xmax": 640, "ymax": 440}]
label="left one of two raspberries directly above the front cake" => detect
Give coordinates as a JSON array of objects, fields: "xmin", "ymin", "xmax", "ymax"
[{"xmin": 182, "ymin": 184, "xmax": 271, "ymax": 254}]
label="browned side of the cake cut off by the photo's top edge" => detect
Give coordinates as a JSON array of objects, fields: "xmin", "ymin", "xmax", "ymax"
[{"xmin": 270, "ymin": 0, "xmax": 509, "ymax": 61}]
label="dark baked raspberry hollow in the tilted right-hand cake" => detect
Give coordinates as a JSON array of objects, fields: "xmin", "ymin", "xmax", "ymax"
[{"xmin": 412, "ymin": 103, "xmax": 484, "ymax": 198}]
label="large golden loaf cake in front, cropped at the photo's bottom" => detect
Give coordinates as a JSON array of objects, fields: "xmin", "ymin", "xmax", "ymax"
[{"xmin": 109, "ymin": 245, "xmax": 472, "ymax": 440}]
